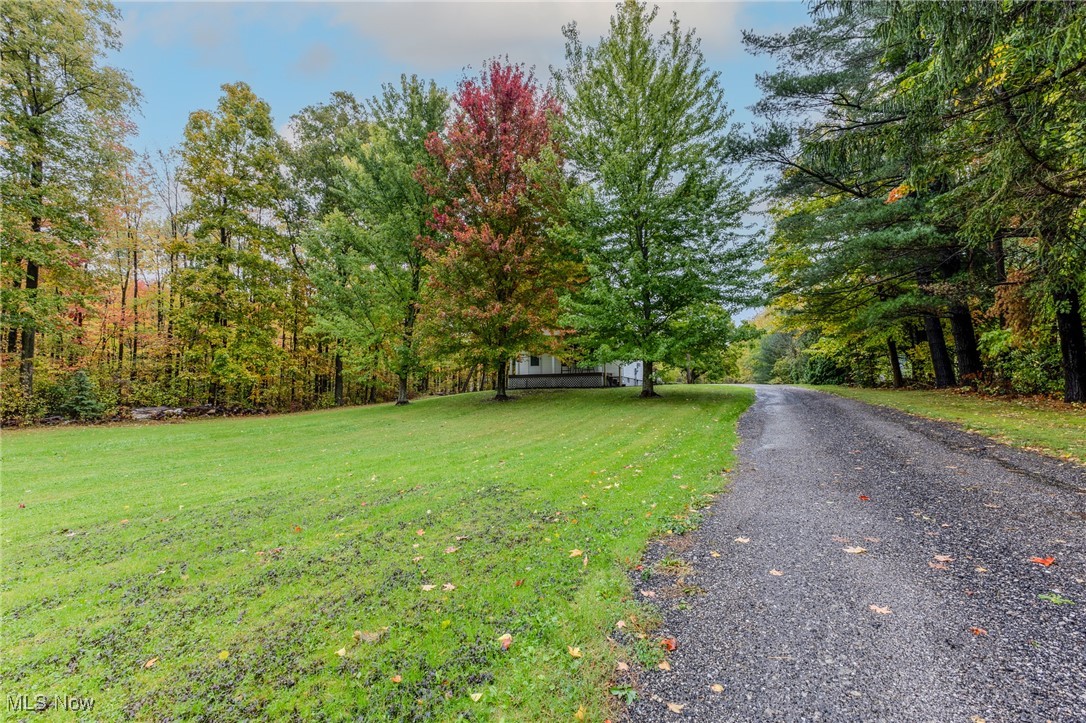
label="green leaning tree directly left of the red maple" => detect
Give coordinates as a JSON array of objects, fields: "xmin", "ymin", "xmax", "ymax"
[{"xmin": 308, "ymin": 76, "xmax": 449, "ymax": 404}]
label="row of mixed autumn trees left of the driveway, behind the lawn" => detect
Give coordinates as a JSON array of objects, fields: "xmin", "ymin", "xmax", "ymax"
[{"xmin": 0, "ymin": 0, "xmax": 756, "ymax": 420}]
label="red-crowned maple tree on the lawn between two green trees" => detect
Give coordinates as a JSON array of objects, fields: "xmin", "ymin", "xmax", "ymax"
[{"xmin": 419, "ymin": 61, "xmax": 579, "ymax": 399}]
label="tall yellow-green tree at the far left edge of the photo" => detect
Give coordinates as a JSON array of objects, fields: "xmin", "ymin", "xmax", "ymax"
[{"xmin": 0, "ymin": 0, "xmax": 138, "ymax": 395}]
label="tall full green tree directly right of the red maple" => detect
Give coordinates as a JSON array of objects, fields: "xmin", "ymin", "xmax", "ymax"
[{"xmin": 558, "ymin": 0, "xmax": 753, "ymax": 397}]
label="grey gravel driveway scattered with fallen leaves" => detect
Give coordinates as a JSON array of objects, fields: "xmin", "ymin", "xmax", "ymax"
[{"xmin": 629, "ymin": 386, "xmax": 1086, "ymax": 723}]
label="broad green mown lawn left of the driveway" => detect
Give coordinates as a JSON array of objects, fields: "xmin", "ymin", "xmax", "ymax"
[{"xmin": 0, "ymin": 386, "xmax": 753, "ymax": 721}]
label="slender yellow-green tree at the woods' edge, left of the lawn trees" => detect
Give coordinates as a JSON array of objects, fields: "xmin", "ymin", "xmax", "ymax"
[{"xmin": 179, "ymin": 83, "xmax": 290, "ymax": 403}]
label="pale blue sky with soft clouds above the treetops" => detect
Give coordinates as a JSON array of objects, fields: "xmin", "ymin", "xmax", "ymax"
[{"xmin": 110, "ymin": 0, "xmax": 807, "ymax": 151}]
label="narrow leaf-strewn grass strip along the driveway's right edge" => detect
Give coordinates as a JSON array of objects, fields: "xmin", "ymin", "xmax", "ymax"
[{"xmin": 810, "ymin": 386, "xmax": 1086, "ymax": 465}]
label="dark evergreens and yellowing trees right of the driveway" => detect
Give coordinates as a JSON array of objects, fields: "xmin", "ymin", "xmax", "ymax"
[{"xmin": 744, "ymin": 0, "xmax": 1086, "ymax": 402}]
